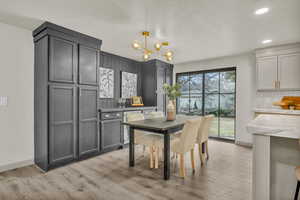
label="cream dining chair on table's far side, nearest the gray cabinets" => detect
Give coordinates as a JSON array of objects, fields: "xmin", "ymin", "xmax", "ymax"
[{"xmin": 127, "ymin": 113, "xmax": 154, "ymax": 168}]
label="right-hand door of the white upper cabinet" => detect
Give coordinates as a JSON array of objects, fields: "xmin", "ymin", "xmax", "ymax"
[{"xmin": 278, "ymin": 53, "xmax": 300, "ymax": 90}]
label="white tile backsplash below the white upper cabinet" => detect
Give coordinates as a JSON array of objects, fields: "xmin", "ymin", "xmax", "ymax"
[{"xmin": 255, "ymin": 91, "xmax": 300, "ymax": 108}]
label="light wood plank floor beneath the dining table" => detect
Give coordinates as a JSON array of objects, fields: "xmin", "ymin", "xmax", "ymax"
[{"xmin": 0, "ymin": 140, "xmax": 252, "ymax": 200}]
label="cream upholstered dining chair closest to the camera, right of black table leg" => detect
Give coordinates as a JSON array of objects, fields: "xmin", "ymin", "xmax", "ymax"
[{"xmin": 153, "ymin": 117, "xmax": 202, "ymax": 178}]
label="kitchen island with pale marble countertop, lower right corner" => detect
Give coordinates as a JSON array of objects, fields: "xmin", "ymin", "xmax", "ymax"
[{"xmin": 247, "ymin": 114, "xmax": 300, "ymax": 200}]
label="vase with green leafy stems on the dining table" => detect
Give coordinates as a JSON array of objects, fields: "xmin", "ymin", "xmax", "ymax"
[{"xmin": 163, "ymin": 83, "xmax": 181, "ymax": 121}]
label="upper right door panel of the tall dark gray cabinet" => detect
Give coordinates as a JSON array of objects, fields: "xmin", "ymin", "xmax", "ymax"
[{"xmin": 78, "ymin": 45, "xmax": 99, "ymax": 85}]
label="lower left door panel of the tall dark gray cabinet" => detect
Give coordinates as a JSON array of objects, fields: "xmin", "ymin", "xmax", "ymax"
[{"xmin": 49, "ymin": 85, "xmax": 76, "ymax": 165}]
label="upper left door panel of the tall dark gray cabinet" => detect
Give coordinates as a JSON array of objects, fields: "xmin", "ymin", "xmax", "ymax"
[{"xmin": 49, "ymin": 36, "xmax": 77, "ymax": 83}]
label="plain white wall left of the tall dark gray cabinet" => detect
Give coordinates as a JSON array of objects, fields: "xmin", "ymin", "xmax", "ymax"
[{"xmin": 0, "ymin": 23, "xmax": 34, "ymax": 171}]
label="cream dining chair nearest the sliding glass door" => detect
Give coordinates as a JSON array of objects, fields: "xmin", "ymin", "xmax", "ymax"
[{"xmin": 196, "ymin": 115, "xmax": 214, "ymax": 165}]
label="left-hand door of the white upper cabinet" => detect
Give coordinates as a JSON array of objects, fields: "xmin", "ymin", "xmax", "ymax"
[{"xmin": 257, "ymin": 56, "xmax": 277, "ymax": 90}]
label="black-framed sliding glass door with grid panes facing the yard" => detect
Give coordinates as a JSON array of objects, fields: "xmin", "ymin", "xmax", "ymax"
[{"xmin": 176, "ymin": 68, "xmax": 236, "ymax": 139}]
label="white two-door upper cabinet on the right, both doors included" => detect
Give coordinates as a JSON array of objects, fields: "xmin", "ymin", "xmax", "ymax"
[{"xmin": 256, "ymin": 43, "xmax": 300, "ymax": 91}]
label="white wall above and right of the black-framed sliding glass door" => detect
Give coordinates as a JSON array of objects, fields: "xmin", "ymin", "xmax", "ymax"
[{"xmin": 174, "ymin": 53, "xmax": 256, "ymax": 144}]
